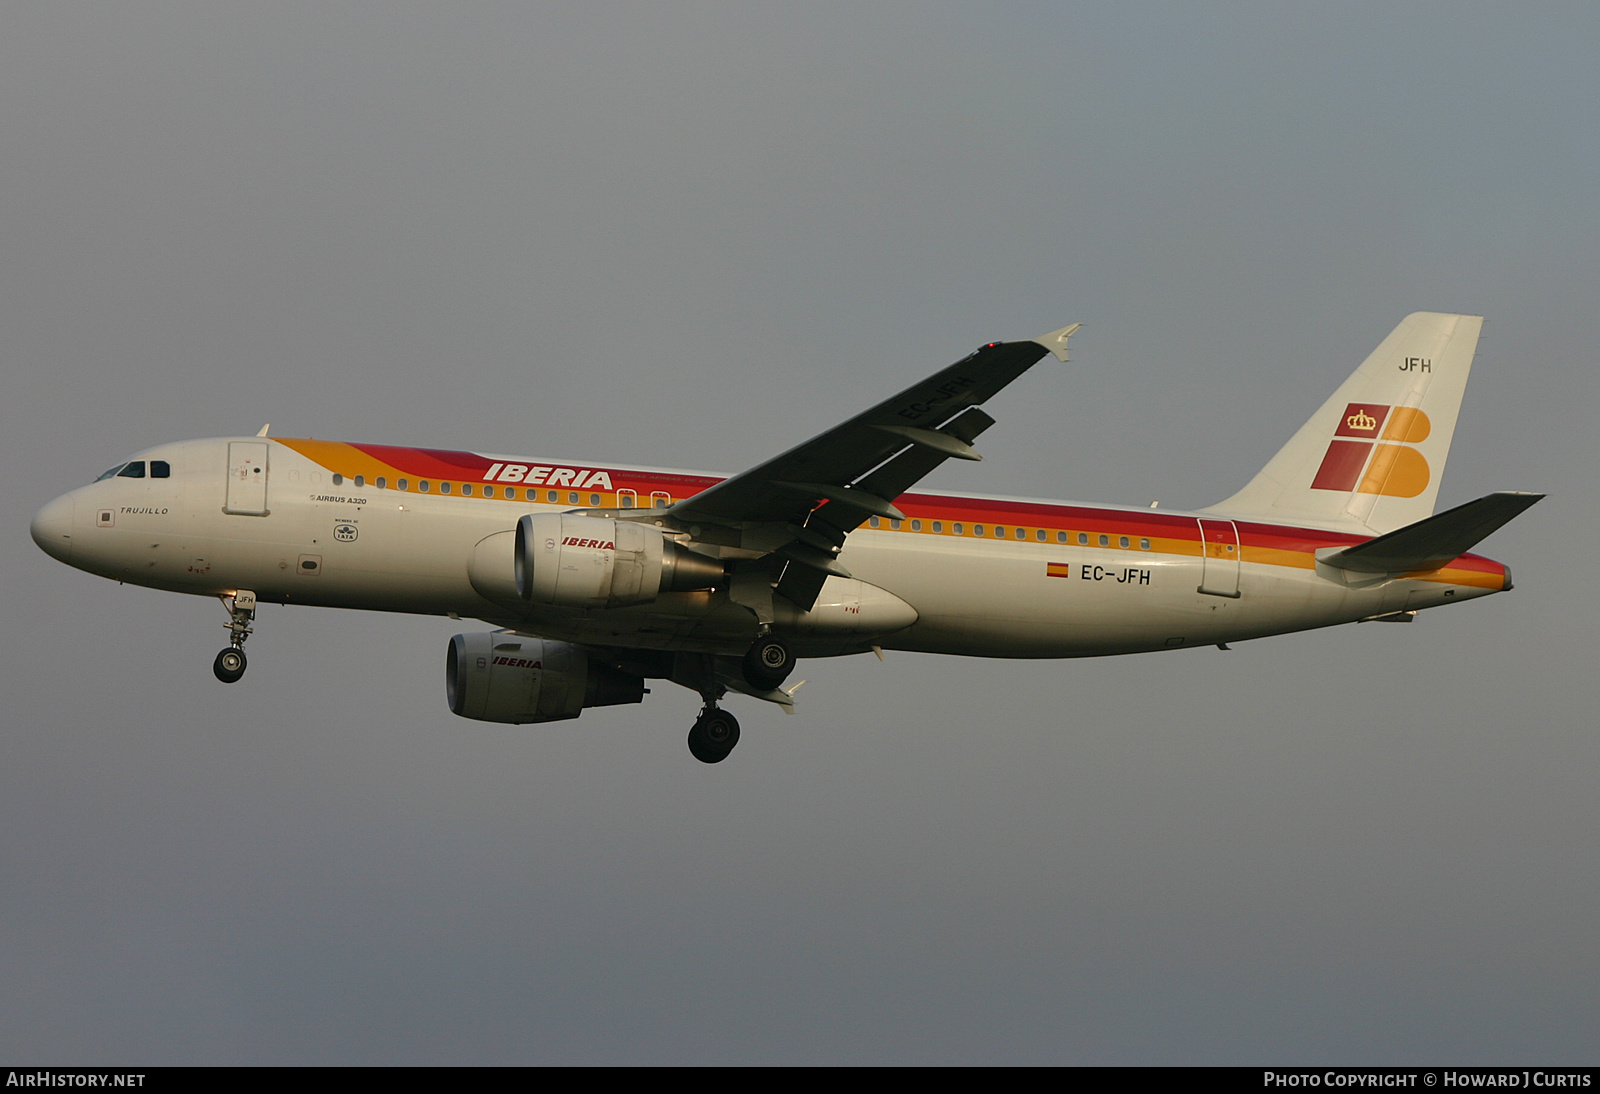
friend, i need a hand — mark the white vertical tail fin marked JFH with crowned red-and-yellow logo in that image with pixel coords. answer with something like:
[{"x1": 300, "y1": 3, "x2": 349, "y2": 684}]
[{"x1": 1203, "y1": 312, "x2": 1483, "y2": 533}]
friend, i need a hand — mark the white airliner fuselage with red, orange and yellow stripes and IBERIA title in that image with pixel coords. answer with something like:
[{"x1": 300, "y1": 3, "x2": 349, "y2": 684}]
[{"x1": 34, "y1": 438, "x2": 1509, "y2": 657}]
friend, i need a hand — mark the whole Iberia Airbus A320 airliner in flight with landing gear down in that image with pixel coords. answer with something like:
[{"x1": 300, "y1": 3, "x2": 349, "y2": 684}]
[{"x1": 32, "y1": 312, "x2": 1542, "y2": 763}]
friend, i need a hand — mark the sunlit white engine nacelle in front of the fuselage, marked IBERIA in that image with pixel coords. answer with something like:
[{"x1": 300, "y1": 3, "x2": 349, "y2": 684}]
[{"x1": 515, "y1": 513, "x2": 723, "y2": 608}]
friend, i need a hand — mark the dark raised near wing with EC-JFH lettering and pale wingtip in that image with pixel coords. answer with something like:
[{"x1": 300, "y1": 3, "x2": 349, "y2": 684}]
[{"x1": 656, "y1": 323, "x2": 1080, "y2": 614}]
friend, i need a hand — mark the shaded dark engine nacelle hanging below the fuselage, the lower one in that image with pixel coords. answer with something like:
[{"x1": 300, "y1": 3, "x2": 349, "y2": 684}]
[{"x1": 445, "y1": 630, "x2": 645, "y2": 725}]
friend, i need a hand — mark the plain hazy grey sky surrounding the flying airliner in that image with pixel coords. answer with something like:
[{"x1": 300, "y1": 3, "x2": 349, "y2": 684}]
[{"x1": 0, "y1": 3, "x2": 1600, "y2": 1064}]
